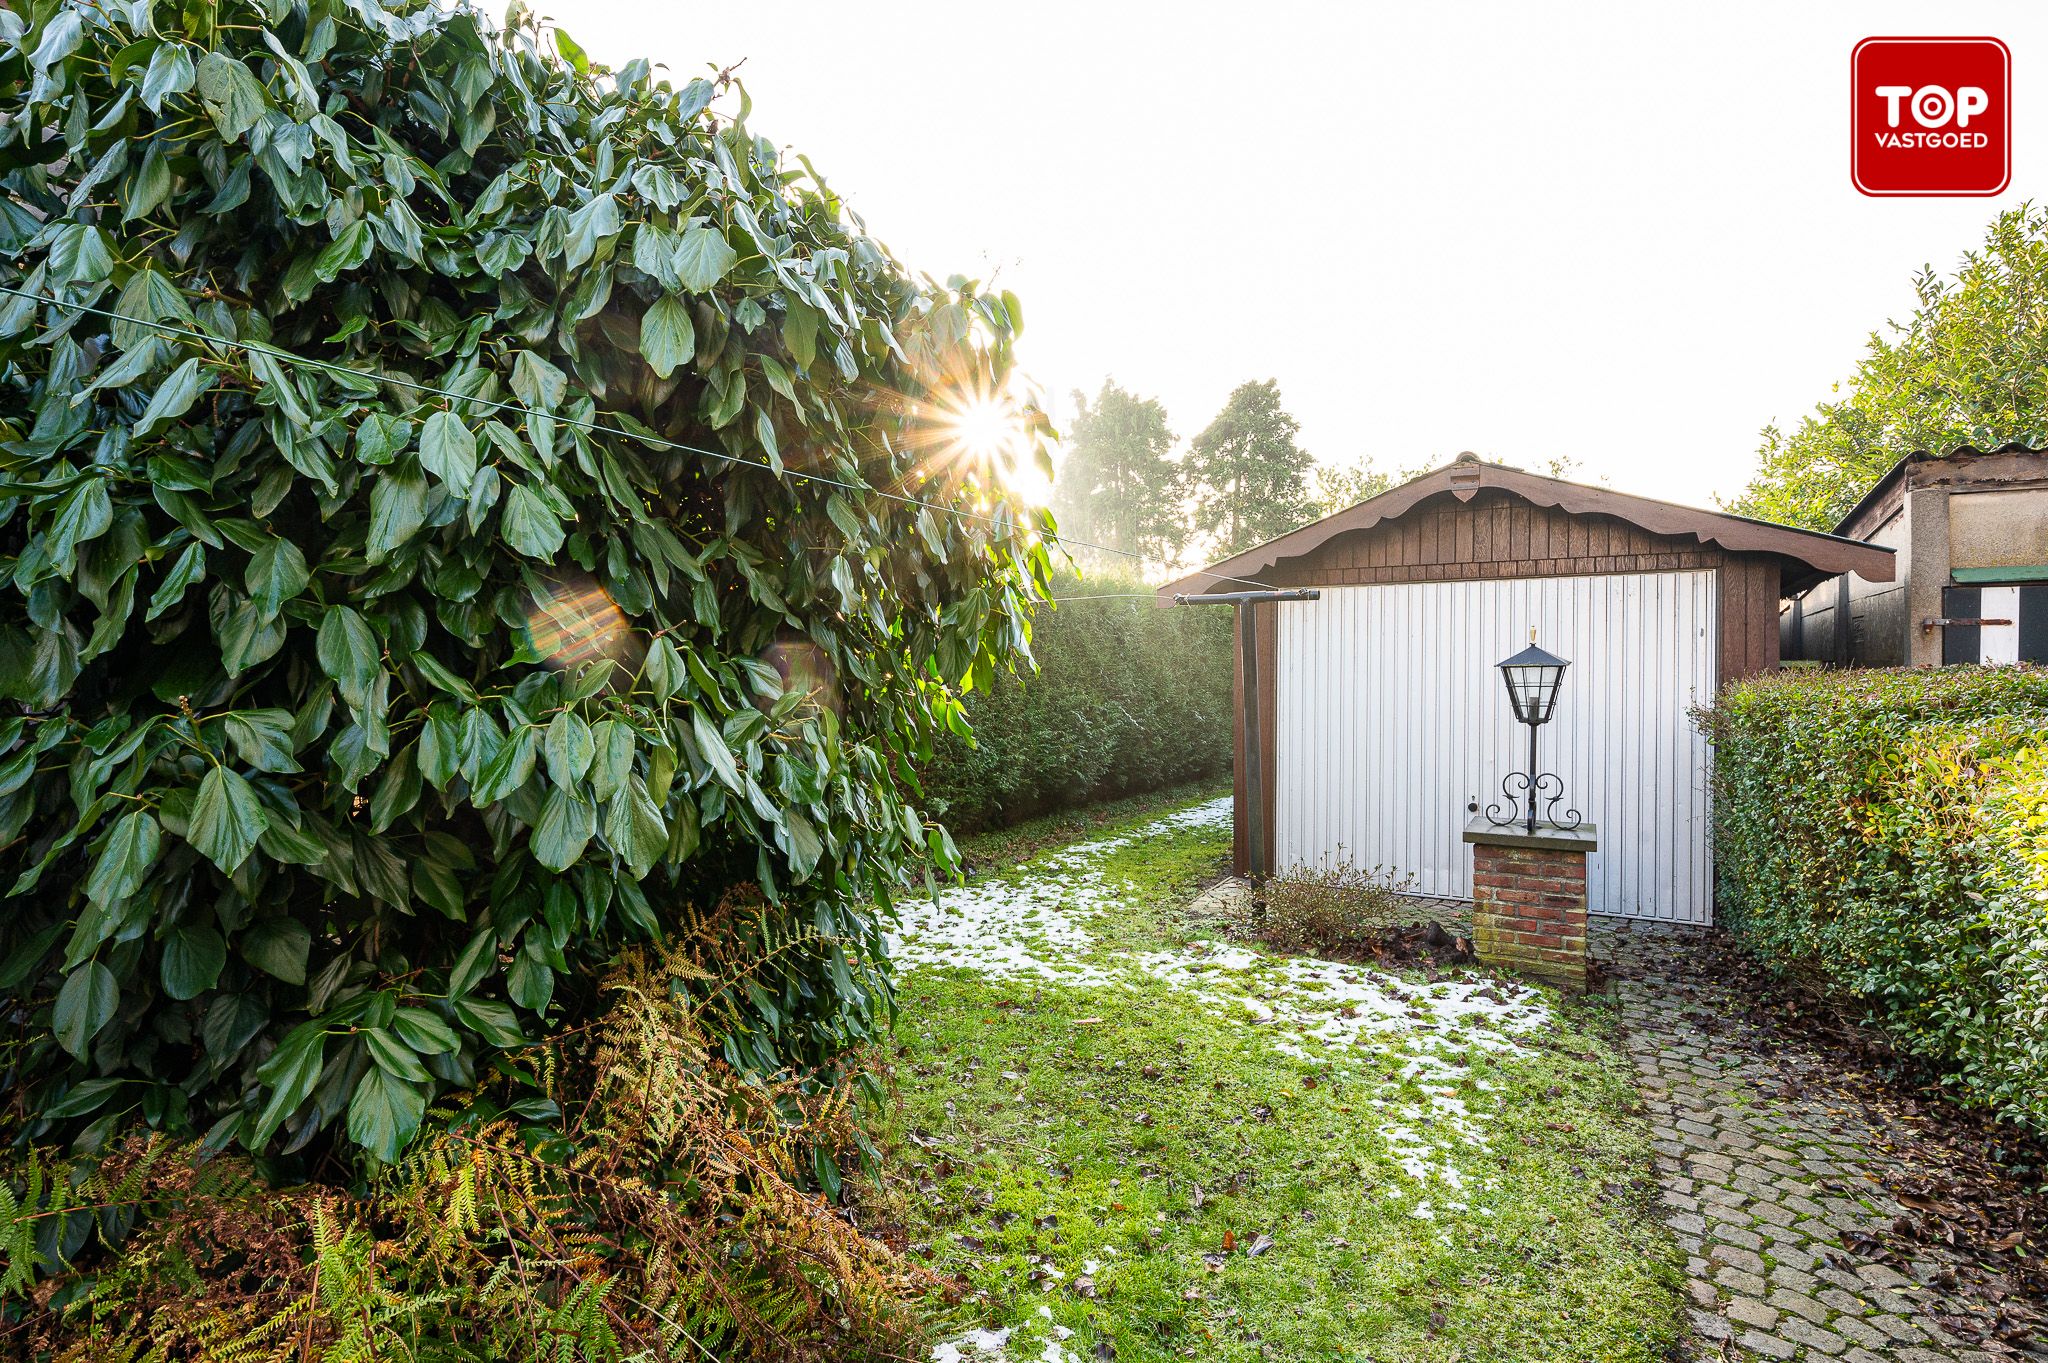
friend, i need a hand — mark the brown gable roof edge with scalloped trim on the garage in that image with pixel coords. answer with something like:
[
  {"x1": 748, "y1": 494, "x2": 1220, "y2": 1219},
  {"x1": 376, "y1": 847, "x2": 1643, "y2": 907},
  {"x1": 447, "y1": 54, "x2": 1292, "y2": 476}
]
[{"x1": 1159, "y1": 454, "x2": 1894, "y2": 600}]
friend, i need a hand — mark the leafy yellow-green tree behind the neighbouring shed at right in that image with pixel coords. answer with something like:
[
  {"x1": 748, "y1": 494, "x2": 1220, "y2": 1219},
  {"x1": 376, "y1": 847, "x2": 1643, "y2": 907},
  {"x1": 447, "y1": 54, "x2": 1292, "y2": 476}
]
[{"x1": 1729, "y1": 205, "x2": 2048, "y2": 530}]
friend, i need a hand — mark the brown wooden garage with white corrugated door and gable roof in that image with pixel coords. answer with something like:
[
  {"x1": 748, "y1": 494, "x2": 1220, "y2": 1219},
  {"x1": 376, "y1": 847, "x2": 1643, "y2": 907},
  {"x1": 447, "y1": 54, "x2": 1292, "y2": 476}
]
[{"x1": 1159, "y1": 454, "x2": 1892, "y2": 923}]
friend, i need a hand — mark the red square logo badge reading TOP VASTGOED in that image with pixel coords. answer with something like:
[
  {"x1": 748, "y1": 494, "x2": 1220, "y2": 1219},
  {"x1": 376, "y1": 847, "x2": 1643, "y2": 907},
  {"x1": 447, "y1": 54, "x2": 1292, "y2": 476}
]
[{"x1": 1849, "y1": 39, "x2": 2013, "y2": 196}]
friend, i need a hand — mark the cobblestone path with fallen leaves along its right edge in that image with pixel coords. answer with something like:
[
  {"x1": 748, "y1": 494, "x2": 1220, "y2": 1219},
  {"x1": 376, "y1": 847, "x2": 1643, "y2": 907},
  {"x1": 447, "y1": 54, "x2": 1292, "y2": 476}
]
[{"x1": 1591, "y1": 921, "x2": 2048, "y2": 1363}]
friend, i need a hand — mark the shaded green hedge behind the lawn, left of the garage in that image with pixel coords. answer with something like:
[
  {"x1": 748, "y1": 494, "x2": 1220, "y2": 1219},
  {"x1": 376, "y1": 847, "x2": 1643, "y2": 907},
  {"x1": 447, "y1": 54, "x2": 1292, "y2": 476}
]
[{"x1": 920, "y1": 577, "x2": 1231, "y2": 833}]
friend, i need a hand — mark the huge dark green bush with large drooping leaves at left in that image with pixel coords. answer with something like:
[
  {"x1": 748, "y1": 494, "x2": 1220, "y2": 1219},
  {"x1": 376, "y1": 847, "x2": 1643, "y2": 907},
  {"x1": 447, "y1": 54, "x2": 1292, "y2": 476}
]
[{"x1": 0, "y1": 0, "x2": 1051, "y2": 1169}]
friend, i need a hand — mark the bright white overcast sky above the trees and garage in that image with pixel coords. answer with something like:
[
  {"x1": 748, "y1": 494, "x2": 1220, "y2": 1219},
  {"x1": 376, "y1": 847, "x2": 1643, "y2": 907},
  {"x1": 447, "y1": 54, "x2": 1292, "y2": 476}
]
[{"x1": 537, "y1": 0, "x2": 2048, "y2": 505}]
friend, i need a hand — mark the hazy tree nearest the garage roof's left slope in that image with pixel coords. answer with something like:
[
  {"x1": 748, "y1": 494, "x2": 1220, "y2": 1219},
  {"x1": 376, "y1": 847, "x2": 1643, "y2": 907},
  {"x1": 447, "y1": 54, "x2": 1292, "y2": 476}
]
[{"x1": 1184, "y1": 379, "x2": 1315, "y2": 555}]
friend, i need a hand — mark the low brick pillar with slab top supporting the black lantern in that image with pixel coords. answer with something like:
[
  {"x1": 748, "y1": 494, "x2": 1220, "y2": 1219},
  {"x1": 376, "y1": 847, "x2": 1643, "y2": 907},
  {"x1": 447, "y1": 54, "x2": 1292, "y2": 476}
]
[{"x1": 1464, "y1": 819, "x2": 1597, "y2": 988}]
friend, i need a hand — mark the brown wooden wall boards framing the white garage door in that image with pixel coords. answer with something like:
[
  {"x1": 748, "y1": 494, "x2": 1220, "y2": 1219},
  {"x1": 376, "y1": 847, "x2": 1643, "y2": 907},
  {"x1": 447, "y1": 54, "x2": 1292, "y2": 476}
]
[{"x1": 1233, "y1": 487, "x2": 1782, "y2": 874}]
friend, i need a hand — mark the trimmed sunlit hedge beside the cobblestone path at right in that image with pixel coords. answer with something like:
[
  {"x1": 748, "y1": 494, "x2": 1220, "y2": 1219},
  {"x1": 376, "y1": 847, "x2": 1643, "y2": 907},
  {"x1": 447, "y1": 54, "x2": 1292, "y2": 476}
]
[{"x1": 1704, "y1": 667, "x2": 2048, "y2": 1132}]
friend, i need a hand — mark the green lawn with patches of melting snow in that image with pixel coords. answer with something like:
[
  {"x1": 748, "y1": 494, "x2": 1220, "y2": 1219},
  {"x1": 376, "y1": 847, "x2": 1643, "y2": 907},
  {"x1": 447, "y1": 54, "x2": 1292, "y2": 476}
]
[{"x1": 885, "y1": 796, "x2": 1681, "y2": 1363}]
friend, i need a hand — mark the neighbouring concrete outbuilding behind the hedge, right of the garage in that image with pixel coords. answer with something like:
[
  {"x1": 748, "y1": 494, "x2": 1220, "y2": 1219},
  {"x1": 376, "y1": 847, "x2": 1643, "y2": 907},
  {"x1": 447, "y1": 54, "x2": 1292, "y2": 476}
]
[{"x1": 1780, "y1": 444, "x2": 2048, "y2": 667}]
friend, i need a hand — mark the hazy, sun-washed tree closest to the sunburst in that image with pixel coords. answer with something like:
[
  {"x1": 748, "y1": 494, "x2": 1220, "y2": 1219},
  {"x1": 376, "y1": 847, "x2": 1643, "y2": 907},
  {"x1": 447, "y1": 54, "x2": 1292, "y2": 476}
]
[{"x1": 1053, "y1": 379, "x2": 1188, "y2": 561}]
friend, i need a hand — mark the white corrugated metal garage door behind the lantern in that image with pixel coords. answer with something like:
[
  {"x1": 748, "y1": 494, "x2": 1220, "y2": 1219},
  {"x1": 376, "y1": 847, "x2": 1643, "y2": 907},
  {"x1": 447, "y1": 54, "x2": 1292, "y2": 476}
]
[{"x1": 1274, "y1": 571, "x2": 1716, "y2": 923}]
